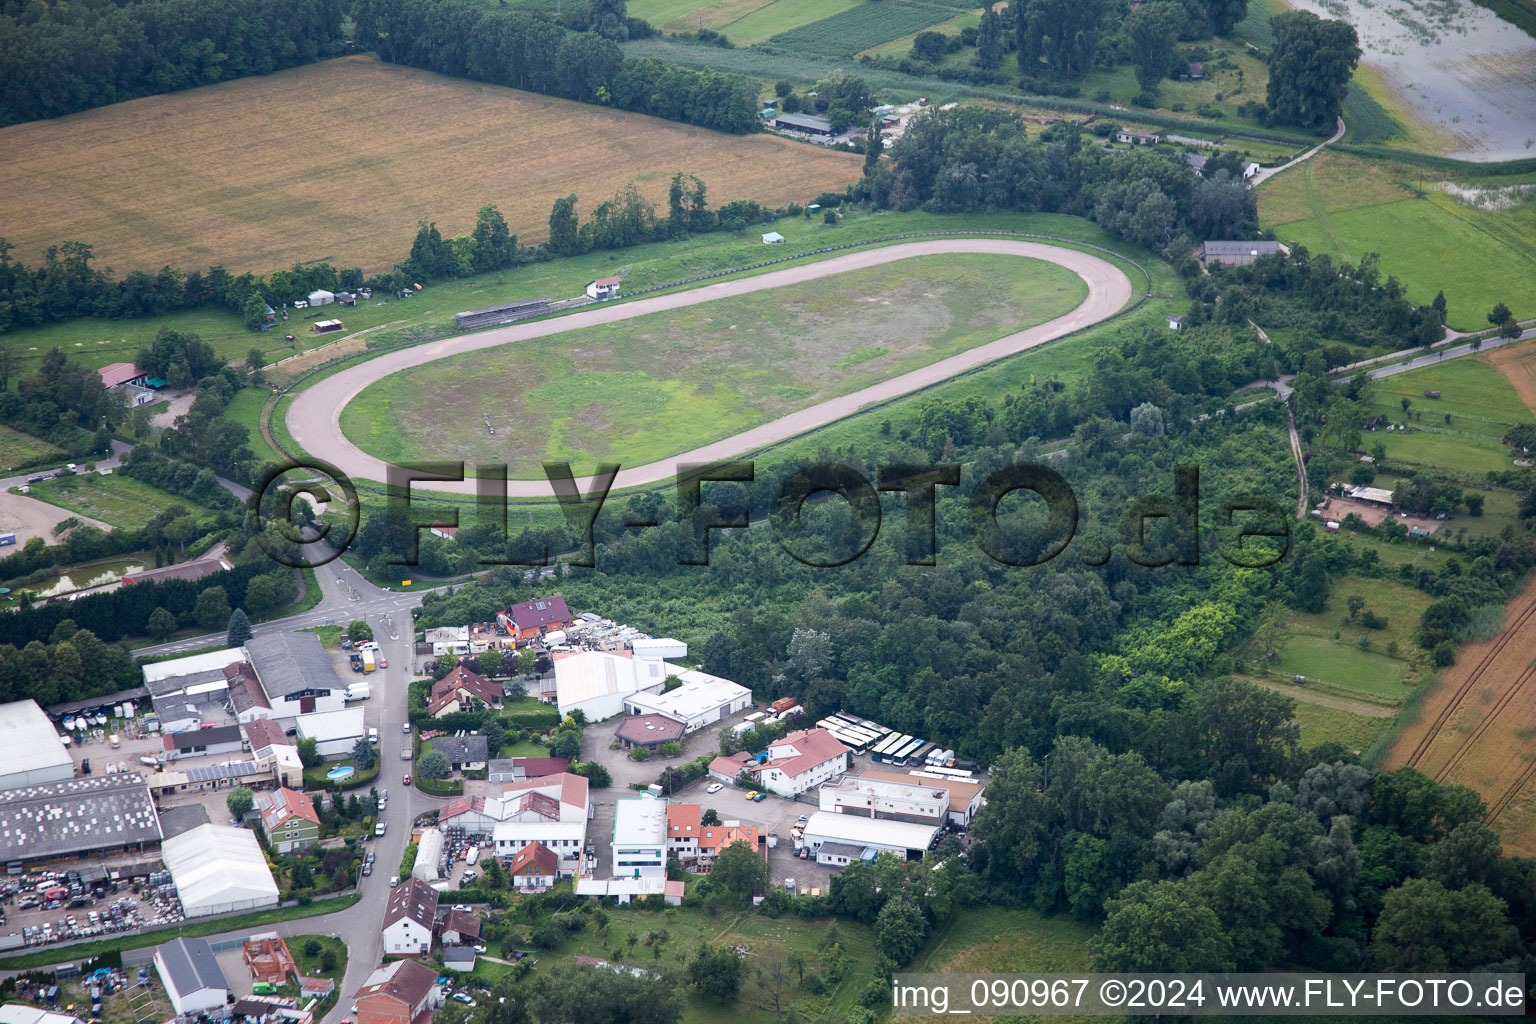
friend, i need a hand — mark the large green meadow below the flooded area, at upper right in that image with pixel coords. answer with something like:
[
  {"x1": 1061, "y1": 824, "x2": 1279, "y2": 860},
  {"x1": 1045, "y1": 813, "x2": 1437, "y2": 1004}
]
[{"x1": 1258, "y1": 152, "x2": 1536, "y2": 322}]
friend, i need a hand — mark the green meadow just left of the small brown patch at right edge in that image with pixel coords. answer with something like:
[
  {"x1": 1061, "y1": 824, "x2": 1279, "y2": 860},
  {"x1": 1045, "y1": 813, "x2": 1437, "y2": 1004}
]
[{"x1": 1364, "y1": 350, "x2": 1536, "y2": 481}]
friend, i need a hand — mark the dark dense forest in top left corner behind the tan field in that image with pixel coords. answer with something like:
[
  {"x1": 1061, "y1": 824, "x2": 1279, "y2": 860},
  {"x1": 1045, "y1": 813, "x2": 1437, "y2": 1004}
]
[{"x1": 0, "y1": 0, "x2": 343, "y2": 124}]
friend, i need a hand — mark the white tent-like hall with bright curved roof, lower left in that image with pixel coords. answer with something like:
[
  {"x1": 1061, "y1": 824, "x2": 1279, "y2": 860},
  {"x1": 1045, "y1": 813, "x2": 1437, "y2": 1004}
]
[{"x1": 160, "y1": 823, "x2": 278, "y2": 918}]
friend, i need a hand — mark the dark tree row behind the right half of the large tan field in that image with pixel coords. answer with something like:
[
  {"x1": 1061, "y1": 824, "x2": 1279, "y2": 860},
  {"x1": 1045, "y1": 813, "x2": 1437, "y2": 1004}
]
[{"x1": 352, "y1": 0, "x2": 757, "y2": 134}]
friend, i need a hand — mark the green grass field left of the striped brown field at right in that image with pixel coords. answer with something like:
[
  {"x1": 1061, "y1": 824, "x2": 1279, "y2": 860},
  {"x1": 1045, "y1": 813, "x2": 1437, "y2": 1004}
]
[{"x1": 1250, "y1": 576, "x2": 1430, "y2": 705}]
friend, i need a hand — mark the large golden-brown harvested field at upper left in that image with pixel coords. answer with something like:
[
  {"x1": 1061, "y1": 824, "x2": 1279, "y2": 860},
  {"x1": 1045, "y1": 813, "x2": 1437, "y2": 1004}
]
[{"x1": 0, "y1": 52, "x2": 860, "y2": 276}]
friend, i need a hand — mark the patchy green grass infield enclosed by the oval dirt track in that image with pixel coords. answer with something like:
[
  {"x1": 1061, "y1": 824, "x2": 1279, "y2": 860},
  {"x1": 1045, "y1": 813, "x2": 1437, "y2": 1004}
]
[{"x1": 341, "y1": 255, "x2": 1087, "y2": 477}]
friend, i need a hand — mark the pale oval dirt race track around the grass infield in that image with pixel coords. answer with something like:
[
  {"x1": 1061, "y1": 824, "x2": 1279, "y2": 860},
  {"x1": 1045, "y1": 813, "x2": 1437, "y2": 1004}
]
[{"x1": 287, "y1": 238, "x2": 1132, "y2": 497}]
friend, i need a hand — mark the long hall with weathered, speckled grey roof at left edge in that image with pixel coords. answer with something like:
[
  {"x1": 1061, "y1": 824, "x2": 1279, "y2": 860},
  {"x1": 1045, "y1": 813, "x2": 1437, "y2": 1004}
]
[{"x1": 0, "y1": 773, "x2": 163, "y2": 866}]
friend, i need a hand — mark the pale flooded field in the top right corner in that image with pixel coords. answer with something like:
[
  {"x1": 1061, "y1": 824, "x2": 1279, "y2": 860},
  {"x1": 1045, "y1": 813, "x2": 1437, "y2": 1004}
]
[{"x1": 1290, "y1": 0, "x2": 1536, "y2": 160}]
